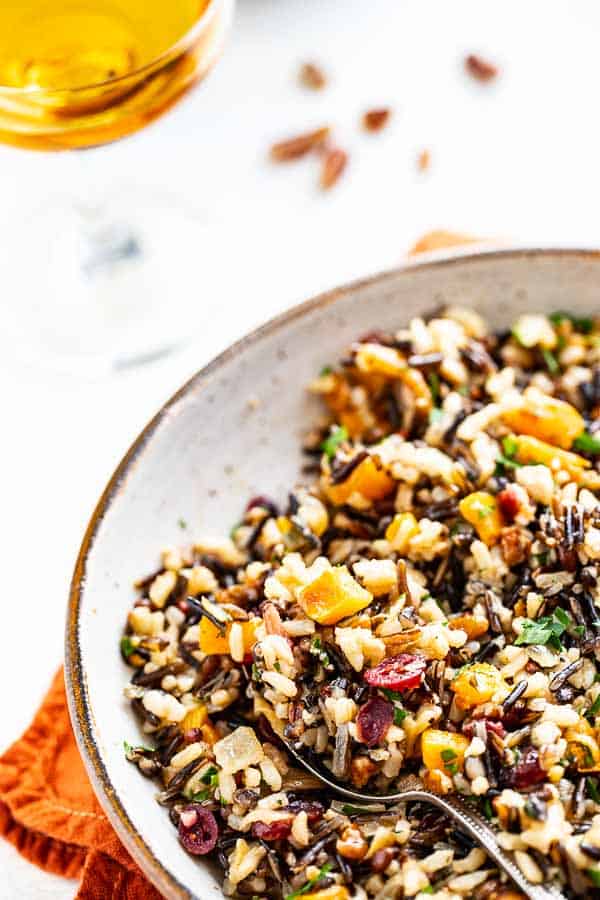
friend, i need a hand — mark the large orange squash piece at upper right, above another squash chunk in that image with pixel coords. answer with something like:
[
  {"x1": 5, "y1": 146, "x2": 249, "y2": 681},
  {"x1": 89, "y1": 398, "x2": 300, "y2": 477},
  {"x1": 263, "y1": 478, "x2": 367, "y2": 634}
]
[{"x1": 502, "y1": 388, "x2": 585, "y2": 450}]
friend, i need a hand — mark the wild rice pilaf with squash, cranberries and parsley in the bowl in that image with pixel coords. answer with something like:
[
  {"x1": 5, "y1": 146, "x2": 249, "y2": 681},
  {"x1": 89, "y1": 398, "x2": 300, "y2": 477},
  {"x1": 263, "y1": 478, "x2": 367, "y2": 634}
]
[{"x1": 121, "y1": 308, "x2": 600, "y2": 900}]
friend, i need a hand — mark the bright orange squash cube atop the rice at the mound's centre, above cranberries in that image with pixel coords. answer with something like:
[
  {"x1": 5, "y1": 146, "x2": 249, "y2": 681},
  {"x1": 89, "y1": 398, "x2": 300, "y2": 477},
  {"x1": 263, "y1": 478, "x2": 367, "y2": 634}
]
[{"x1": 298, "y1": 566, "x2": 373, "y2": 625}]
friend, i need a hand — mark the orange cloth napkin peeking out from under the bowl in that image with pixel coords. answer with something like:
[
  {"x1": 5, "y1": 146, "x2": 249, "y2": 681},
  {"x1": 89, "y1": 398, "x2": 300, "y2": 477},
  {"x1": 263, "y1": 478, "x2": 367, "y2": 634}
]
[{"x1": 0, "y1": 231, "x2": 475, "y2": 900}]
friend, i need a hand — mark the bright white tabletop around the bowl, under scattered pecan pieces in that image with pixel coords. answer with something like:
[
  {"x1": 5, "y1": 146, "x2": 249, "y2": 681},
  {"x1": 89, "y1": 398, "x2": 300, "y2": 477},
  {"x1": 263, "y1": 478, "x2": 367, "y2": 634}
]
[{"x1": 0, "y1": 0, "x2": 600, "y2": 900}]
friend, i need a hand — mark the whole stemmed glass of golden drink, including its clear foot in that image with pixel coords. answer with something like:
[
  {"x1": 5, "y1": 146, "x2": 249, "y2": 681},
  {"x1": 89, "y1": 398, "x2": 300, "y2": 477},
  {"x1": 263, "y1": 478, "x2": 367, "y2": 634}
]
[{"x1": 0, "y1": 0, "x2": 235, "y2": 375}]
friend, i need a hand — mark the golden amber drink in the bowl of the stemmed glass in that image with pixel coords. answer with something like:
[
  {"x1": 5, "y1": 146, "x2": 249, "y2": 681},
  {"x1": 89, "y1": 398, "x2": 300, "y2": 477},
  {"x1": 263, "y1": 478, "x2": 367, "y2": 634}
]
[{"x1": 0, "y1": 0, "x2": 226, "y2": 150}]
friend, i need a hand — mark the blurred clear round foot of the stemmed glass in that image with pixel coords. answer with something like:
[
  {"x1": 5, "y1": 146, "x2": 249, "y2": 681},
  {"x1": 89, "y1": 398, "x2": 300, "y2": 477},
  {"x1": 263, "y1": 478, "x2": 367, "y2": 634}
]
[{"x1": 0, "y1": 188, "x2": 223, "y2": 376}]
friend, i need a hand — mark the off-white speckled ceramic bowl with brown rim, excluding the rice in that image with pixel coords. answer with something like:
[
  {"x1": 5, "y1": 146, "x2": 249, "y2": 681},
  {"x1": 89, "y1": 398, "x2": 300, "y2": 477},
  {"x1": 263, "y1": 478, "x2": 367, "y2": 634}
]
[{"x1": 66, "y1": 250, "x2": 600, "y2": 900}]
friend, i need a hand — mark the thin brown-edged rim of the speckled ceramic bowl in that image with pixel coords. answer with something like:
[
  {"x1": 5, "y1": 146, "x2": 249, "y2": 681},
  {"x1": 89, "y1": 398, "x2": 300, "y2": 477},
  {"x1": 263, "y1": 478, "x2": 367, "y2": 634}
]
[{"x1": 65, "y1": 244, "x2": 600, "y2": 900}]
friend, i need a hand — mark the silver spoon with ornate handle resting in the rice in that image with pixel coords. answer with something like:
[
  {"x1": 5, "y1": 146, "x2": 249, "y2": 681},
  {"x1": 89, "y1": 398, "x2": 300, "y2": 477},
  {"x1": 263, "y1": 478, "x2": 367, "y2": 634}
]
[{"x1": 285, "y1": 741, "x2": 564, "y2": 900}]
